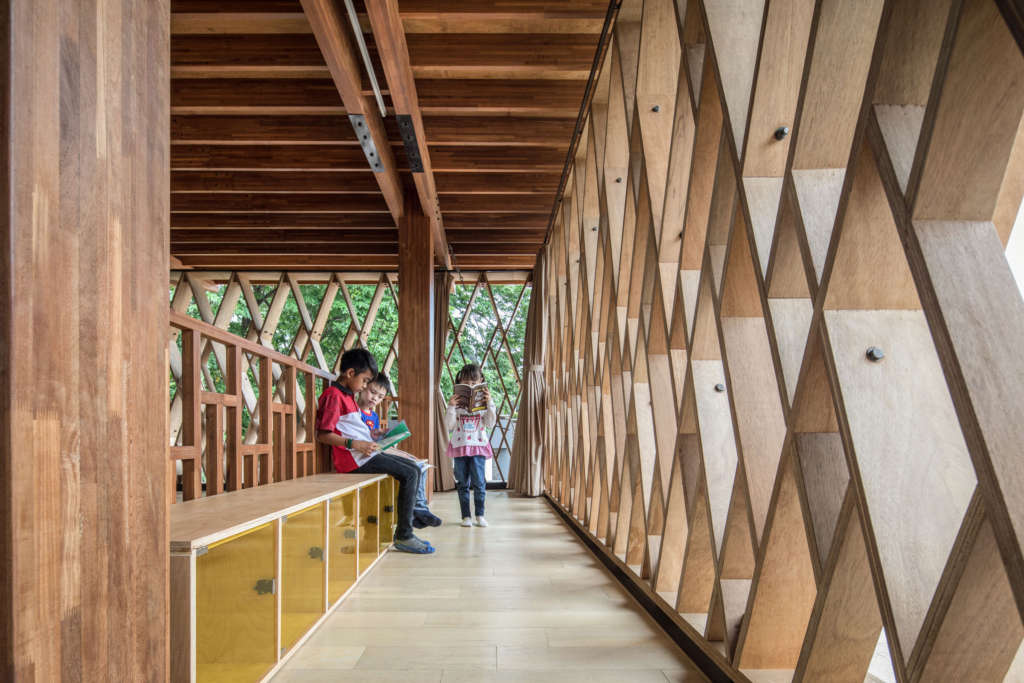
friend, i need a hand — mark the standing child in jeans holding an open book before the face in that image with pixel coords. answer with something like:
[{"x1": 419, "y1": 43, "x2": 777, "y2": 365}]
[{"x1": 444, "y1": 364, "x2": 498, "y2": 526}]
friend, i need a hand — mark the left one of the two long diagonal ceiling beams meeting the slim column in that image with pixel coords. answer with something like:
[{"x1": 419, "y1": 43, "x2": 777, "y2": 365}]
[{"x1": 301, "y1": 0, "x2": 404, "y2": 224}]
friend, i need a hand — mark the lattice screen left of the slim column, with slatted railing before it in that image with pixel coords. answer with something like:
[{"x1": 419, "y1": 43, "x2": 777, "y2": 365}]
[{"x1": 168, "y1": 271, "x2": 398, "y2": 500}]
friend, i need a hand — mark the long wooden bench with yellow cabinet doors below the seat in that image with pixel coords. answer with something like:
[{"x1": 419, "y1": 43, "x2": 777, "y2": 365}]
[{"x1": 170, "y1": 474, "x2": 397, "y2": 682}]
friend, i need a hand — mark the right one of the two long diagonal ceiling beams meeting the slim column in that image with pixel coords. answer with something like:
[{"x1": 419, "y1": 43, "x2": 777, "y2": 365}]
[{"x1": 366, "y1": 0, "x2": 452, "y2": 267}]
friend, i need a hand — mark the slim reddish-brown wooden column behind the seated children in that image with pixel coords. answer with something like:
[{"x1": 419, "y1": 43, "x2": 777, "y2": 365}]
[{"x1": 398, "y1": 195, "x2": 435, "y2": 481}]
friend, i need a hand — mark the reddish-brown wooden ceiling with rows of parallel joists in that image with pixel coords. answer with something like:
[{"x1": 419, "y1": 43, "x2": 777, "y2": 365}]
[{"x1": 170, "y1": 0, "x2": 608, "y2": 269}]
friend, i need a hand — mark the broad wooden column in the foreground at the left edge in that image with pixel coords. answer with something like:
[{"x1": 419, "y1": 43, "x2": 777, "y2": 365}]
[{"x1": 0, "y1": 0, "x2": 170, "y2": 681}]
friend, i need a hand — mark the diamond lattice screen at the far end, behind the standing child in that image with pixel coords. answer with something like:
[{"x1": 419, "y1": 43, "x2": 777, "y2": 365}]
[{"x1": 439, "y1": 272, "x2": 529, "y2": 481}]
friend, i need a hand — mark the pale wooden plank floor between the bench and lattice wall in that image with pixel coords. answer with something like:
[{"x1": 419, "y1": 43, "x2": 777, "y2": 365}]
[{"x1": 273, "y1": 492, "x2": 707, "y2": 683}]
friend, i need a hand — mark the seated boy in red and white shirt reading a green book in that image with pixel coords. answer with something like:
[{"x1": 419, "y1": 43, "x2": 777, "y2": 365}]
[{"x1": 316, "y1": 348, "x2": 434, "y2": 555}]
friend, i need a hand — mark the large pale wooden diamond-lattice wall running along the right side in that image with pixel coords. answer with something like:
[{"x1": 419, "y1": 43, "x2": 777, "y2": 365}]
[{"x1": 538, "y1": 0, "x2": 1024, "y2": 683}]
